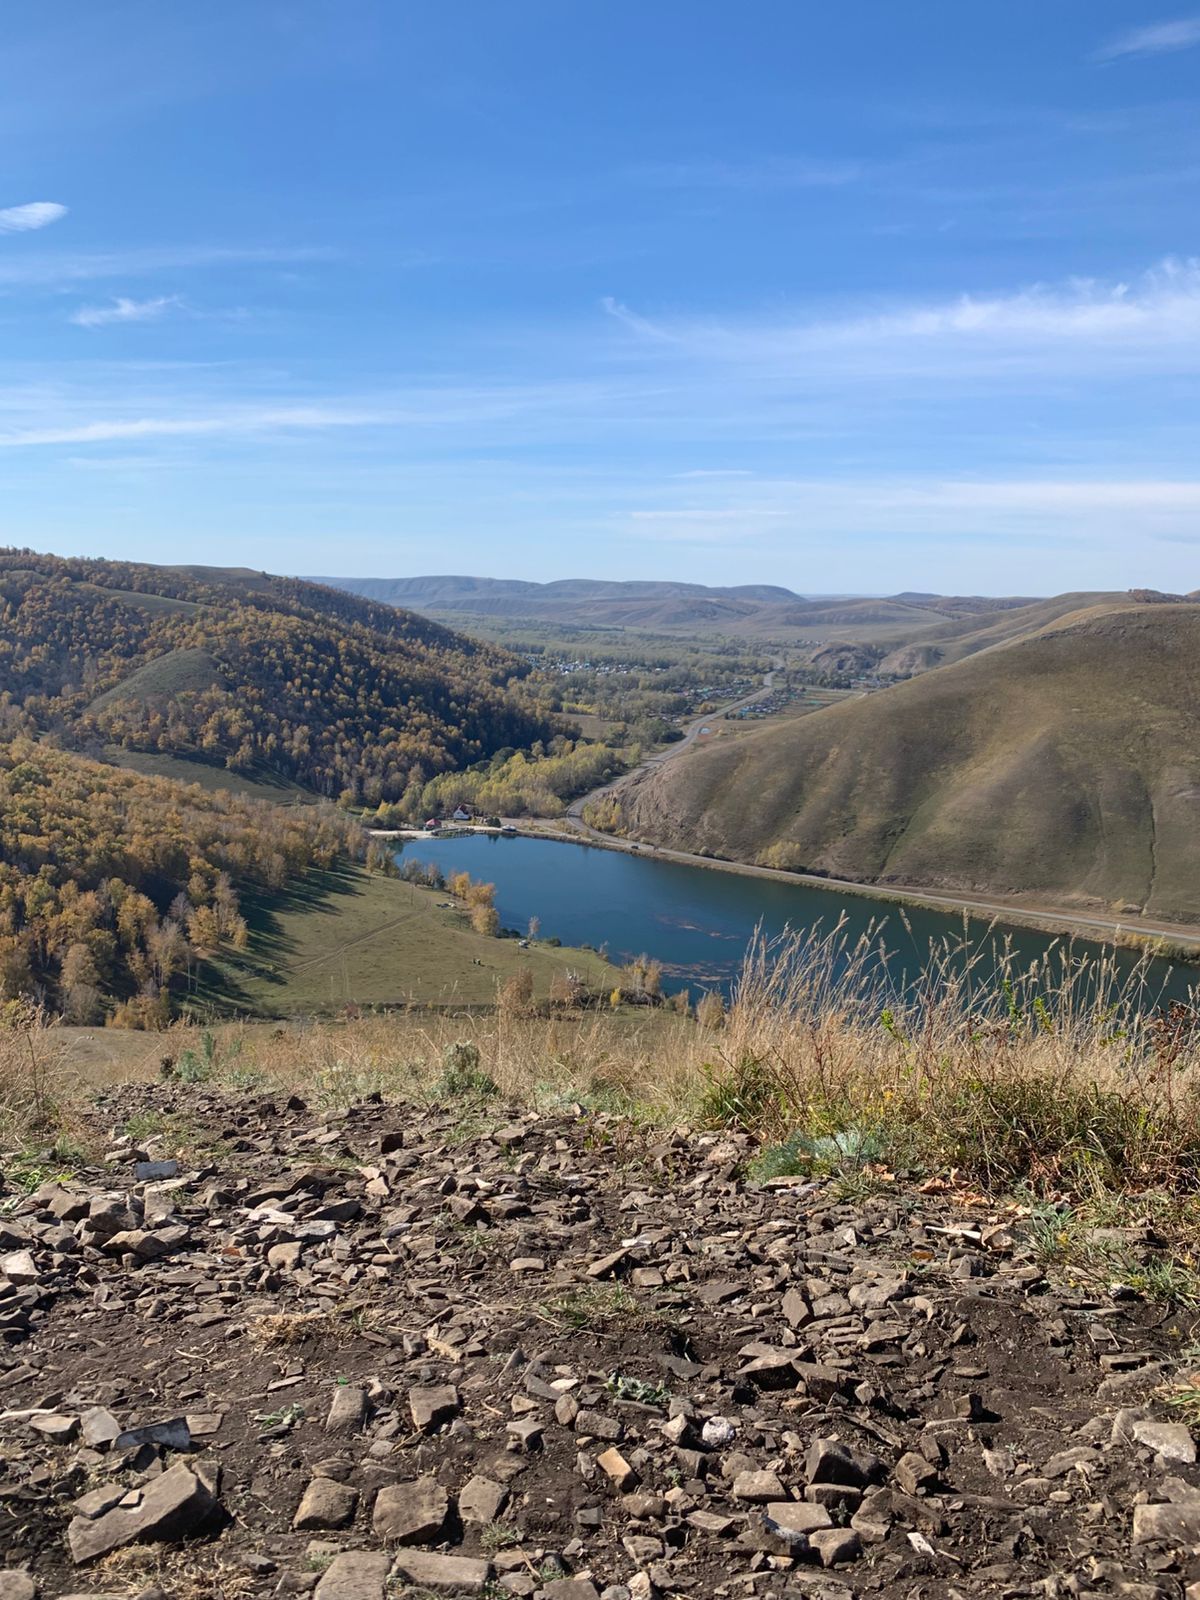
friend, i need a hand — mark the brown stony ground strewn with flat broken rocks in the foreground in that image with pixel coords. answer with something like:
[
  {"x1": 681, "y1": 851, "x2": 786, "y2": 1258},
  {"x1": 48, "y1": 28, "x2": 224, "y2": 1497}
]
[{"x1": 0, "y1": 1085, "x2": 1200, "y2": 1600}]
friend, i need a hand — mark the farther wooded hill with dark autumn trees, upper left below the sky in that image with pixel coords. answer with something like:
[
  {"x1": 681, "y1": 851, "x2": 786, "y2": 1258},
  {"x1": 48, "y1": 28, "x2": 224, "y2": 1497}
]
[{"x1": 0, "y1": 550, "x2": 554, "y2": 805}]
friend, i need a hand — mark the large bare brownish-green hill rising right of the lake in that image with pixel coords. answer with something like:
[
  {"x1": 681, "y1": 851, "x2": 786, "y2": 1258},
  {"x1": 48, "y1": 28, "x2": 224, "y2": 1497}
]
[{"x1": 624, "y1": 595, "x2": 1200, "y2": 920}]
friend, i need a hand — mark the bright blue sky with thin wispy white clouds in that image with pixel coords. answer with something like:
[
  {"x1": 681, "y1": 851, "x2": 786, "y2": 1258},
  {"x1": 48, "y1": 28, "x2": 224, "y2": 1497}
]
[{"x1": 0, "y1": 0, "x2": 1200, "y2": 594}]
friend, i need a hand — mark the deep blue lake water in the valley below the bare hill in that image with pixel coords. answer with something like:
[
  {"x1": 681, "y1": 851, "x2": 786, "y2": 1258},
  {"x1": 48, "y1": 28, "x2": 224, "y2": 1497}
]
[{"x1": 397, "y1": 834, "x2": 1200, "y2": 1000}]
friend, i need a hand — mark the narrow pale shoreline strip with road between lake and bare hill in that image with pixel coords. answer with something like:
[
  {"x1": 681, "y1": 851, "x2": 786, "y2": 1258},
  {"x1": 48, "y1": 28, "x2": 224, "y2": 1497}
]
[{"x1": 380, "y1": 813, "x2": 1200, "y2": 966}]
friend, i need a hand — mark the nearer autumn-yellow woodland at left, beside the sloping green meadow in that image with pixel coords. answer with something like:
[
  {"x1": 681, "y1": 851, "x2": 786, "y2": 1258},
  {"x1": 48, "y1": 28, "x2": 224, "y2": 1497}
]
[{"x1": 0, "y1": 736, "x2": 365, "y2": 1026}]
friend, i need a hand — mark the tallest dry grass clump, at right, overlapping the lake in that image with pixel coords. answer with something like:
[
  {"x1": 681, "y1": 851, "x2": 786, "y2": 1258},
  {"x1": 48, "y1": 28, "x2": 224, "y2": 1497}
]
[{"x1": 706, "y1": 925, "x2": 1200, "y2": 1189}]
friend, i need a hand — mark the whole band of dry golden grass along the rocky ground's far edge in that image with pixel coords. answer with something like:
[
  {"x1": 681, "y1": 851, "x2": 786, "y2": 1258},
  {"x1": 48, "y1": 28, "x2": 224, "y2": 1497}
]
[{"x1": 14, "y1": 925, "x2": 1200, "y2": 1195}]
